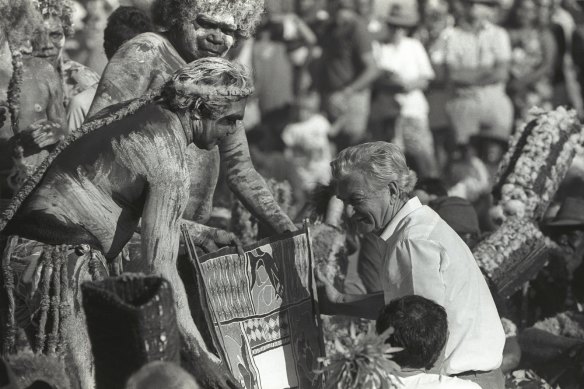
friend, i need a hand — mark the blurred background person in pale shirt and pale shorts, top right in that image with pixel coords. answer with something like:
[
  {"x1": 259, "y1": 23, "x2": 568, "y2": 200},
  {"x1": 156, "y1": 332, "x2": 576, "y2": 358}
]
[{"x1": 433, "y1": 0, "x2": 513, "y2": 164}]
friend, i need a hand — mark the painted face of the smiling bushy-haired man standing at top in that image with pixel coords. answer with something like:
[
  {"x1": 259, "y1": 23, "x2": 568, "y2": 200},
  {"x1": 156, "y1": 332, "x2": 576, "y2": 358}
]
[{"x1": 175, "y1": 14, "x2": 237, "y2": 62}]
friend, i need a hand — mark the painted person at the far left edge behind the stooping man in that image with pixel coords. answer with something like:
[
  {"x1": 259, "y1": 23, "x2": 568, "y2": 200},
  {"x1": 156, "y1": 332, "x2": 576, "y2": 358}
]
[{"x1": 0, "y1": 2, "x2": 66, "y2": 203}]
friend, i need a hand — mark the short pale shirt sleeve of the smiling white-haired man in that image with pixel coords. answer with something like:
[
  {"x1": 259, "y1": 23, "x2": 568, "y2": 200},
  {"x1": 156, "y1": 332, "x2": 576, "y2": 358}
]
[{"x1": 395, "y1": 239, "x2": 446, "y2": 306}]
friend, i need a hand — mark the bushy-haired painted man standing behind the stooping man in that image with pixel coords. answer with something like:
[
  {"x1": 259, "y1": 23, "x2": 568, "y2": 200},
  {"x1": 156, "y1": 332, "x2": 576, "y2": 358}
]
[{"x1": 88, "y1": 0, "x2": 295, "y2": 238}]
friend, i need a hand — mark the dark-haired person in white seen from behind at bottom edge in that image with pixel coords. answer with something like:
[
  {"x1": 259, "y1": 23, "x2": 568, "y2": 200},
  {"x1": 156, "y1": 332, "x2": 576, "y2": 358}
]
[{"x1": 376, "y1": 295, "x2": 480, "y2": 389}]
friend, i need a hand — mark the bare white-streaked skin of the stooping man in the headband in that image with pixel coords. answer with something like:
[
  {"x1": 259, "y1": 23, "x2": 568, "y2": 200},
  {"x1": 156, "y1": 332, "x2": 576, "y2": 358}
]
[{"x1": 3, "y1": 100, "x2": 245, "y2": 388}]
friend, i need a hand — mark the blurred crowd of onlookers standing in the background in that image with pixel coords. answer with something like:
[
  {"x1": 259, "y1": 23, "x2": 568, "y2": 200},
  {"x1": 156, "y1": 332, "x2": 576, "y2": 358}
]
[{"x1": 6, "y1": 0, "x2": 584, "y2": 230}]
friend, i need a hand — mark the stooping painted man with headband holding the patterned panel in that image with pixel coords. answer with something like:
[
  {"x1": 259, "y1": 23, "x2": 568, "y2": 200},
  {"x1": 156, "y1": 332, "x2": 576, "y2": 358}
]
[{"x1": 0, "y1": 58, "x2": 253, "y2": 388}]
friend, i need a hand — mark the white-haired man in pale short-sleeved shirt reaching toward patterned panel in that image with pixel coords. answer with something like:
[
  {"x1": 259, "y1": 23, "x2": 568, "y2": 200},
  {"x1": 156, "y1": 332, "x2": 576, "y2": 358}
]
[{"x1": 319, "y1": 142, "x2": 505, "y2": 389}]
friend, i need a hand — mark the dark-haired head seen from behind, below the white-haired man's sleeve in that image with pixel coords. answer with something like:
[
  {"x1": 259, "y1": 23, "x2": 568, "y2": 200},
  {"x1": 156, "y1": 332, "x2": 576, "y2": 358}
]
[{"x1": 376, "y1": 295, "x2": 448, "y2": 369}]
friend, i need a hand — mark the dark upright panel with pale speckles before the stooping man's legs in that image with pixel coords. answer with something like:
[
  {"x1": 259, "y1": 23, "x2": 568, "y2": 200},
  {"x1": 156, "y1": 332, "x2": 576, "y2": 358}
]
[{"x1": 81, "y1": 274, "x2": 180, "y2": 389}]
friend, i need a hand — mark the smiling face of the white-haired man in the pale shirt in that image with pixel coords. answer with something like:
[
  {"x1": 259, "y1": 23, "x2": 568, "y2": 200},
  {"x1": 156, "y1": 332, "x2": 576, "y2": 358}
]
[{"x1": 336, "y1": 172, "x2": 392, "y2": 233}]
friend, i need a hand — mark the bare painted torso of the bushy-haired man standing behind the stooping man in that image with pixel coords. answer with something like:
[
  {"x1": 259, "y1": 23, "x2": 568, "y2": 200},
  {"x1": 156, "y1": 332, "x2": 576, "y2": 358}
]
[{"x1": 88, "y1": 33, "x2": 219, "y2": 223}]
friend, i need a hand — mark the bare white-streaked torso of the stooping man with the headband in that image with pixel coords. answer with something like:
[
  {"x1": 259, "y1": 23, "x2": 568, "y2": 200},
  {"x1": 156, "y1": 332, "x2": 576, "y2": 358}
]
[{"x1": 8, "y1": 104, "x2": 189, "y2": 259}]
